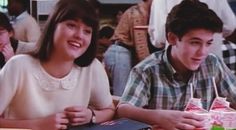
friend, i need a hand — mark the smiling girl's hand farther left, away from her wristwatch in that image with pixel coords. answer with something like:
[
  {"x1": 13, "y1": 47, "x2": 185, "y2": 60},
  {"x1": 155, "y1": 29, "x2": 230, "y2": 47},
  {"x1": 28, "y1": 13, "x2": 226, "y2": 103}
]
[{"x1": 33, "y1": 113, "x2": 69, "y2": 130}]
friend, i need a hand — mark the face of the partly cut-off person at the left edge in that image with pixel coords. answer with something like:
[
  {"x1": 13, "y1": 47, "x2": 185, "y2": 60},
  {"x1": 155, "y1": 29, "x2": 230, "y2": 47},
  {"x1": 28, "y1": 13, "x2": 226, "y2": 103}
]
[{"x1": 0, "y1": 27, "x2": 12, "y2": 52}]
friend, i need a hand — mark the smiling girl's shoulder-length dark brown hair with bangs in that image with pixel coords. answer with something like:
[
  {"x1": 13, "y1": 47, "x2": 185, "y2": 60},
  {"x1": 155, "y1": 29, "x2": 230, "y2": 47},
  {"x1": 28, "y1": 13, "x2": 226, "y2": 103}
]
[{"x1": 32, "y1": 0, "x2": 98, "y2": 67}]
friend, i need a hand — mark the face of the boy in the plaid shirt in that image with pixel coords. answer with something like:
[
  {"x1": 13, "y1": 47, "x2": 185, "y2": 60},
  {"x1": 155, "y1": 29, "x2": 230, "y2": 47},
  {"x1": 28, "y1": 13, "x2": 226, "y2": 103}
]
[{"x1": 168, "y1": 29, "x2": 214, "y2": 72}]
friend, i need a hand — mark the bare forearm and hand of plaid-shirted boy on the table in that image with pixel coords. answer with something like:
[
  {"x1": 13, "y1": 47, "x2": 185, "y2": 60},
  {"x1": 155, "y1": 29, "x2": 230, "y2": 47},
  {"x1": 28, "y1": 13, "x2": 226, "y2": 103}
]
[{"x1": 117, "y1": 104, "x2": 203, "y2": 130}]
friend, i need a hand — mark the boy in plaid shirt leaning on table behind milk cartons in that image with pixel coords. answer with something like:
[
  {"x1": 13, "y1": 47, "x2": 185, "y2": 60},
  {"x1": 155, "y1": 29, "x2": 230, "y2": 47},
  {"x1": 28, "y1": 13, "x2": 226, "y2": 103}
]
[{"x1": 117, "y1": 0, "x2": 236, "y2": 130}]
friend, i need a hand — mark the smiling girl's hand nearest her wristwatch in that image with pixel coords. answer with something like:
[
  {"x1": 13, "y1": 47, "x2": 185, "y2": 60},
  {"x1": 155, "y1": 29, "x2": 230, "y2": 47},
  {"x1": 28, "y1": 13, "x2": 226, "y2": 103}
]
[{"x1": 65, "y1": 106, "x2": 92, "y2": 126}]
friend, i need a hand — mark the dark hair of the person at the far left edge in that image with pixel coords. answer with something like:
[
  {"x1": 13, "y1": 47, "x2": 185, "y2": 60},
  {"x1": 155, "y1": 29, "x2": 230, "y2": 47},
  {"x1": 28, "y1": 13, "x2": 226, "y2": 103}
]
[{"x1": 0, "y1": 12, "x2": 13, "y2": 32}]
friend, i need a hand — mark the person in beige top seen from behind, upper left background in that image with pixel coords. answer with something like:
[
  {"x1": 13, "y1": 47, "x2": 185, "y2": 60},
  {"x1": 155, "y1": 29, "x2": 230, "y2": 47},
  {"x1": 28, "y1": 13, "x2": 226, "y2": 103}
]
[{"x1": 7, "y1": 0, "x2": 41, "y2": 43}]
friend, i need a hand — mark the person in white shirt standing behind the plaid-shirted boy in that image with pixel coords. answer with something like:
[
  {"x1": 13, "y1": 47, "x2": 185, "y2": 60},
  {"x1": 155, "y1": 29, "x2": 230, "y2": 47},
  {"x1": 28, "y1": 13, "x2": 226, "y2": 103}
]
[{"x1": 149, "y1": 0, "x2": 236, "y2": 58}]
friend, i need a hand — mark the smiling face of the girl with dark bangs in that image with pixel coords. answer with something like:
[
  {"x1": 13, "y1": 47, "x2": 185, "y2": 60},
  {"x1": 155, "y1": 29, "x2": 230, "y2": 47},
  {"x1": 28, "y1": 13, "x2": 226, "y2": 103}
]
[{"x1": 53, "y1": 20, "x2": 93, "y2": 60}]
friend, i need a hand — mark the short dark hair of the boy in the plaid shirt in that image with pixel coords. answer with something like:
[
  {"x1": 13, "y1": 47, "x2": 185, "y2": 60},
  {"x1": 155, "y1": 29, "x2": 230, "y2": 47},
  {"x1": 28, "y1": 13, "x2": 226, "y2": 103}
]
[{"x1": 166, "y1": 0, "x2": 223, "y2": 40}]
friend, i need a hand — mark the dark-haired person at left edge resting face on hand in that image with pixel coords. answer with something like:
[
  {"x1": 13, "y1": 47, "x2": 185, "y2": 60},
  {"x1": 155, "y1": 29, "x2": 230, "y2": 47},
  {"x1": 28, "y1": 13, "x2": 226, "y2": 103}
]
[{"x1": 0, "y1": 12, "x2": 35, "y2": 69}]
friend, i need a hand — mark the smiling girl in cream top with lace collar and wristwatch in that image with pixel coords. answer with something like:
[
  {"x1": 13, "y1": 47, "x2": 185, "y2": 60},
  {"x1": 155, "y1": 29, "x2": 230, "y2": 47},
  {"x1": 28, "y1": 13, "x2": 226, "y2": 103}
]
[{"x1": 0, "y1": 0, "x2": 115, "y2": 130}]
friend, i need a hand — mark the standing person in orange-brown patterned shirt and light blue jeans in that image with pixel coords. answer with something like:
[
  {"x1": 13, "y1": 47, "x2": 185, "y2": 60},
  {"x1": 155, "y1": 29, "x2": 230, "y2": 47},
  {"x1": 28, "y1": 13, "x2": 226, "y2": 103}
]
[{"x1": 104, "y1": 0, "x2": 157, "y2": 96}]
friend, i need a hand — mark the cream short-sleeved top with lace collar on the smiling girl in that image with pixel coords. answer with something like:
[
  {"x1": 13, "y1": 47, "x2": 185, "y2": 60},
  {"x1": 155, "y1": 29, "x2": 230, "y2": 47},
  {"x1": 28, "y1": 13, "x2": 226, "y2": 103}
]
[{"x1": 0, "y1": 55, "x2": 112, "y2": 119}]
